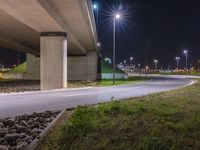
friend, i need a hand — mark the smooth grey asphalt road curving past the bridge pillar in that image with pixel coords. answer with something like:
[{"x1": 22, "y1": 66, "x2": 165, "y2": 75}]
[{"x1": 0, "y1": 77, "x2": 192, "y2": 118}]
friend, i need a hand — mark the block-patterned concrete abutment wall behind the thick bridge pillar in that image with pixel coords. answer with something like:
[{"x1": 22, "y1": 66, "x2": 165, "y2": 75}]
[{"x1": 24, "y1": 51, "x2": 97, "y2": 81}]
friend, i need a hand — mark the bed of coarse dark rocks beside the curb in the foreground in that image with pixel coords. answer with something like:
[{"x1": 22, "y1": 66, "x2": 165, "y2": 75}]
[{"x1": 0, "y1": 111, "x2": 60, "y2": 150}]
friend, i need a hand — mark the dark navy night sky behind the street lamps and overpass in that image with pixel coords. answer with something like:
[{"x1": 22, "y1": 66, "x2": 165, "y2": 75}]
[{"x1": 0, "y1": 0, "x2": 200, "y2": 67}]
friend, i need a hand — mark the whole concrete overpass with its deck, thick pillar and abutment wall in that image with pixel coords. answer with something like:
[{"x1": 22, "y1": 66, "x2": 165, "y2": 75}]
[{"x1": 0, "y1": 0, "x2": 97, "y2": 90}]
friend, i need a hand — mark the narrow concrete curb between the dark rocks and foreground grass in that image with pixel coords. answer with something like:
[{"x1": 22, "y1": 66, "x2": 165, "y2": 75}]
[{"x1": 27, "y1": 109, "x2": 66, "y2": 150}]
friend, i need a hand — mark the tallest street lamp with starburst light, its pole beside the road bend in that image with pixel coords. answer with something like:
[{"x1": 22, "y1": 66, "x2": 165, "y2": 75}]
[{"x1": 113, "y1": 13, "x2": 121, "y2": 84}]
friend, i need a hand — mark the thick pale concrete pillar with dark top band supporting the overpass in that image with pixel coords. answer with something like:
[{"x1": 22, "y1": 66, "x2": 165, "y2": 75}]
[{"x1": 40, "y1": 32, "x2": 67, "y2": 90}]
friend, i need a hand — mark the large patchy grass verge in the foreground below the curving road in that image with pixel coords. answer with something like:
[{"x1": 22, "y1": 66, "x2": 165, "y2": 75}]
[{"x1": 37, "y1": 81, "x2": 200, "y2": 150}]
